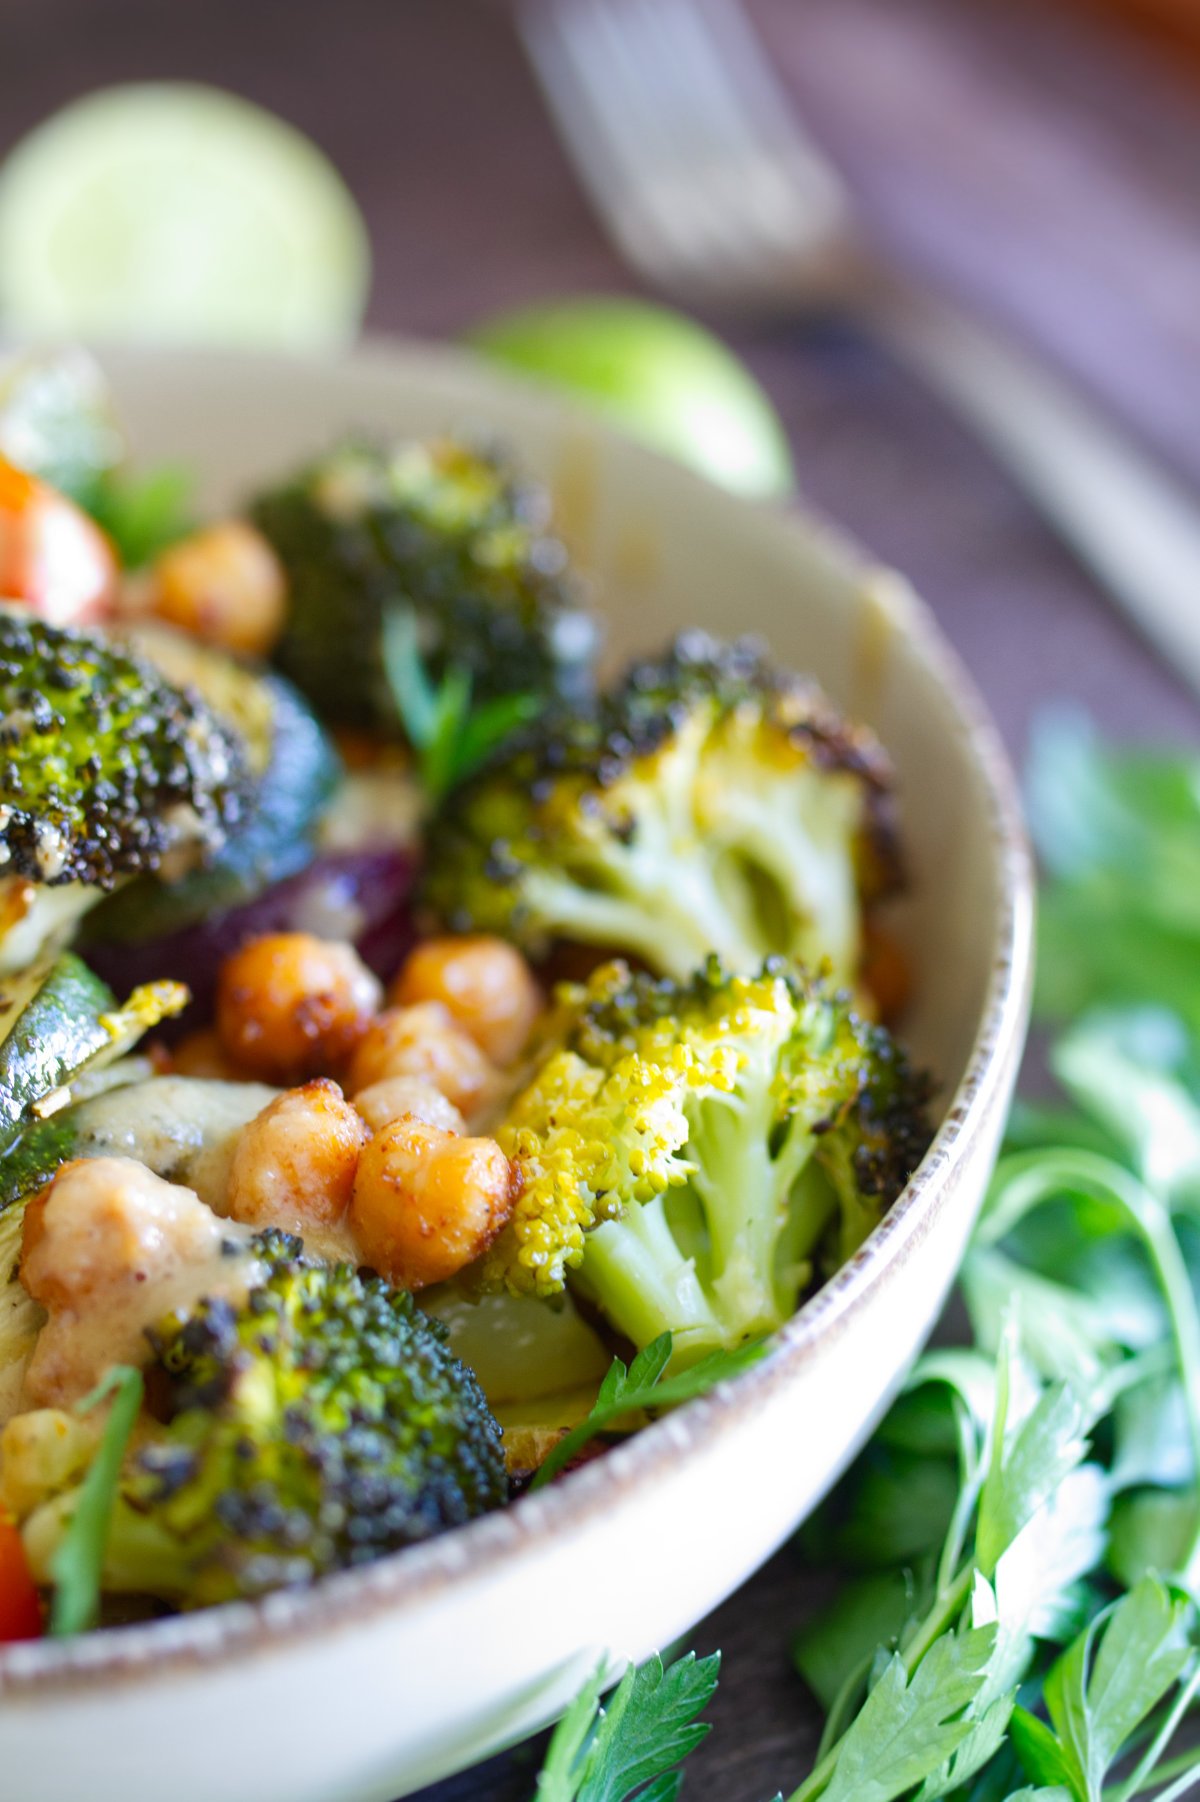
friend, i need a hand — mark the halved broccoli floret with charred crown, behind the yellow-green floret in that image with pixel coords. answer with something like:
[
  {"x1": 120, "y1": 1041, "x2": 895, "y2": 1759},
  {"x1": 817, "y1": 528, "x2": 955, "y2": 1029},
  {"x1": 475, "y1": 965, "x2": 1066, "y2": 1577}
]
[{"x1": 425, "y1": 633, "x2": 899, "y2": 980}]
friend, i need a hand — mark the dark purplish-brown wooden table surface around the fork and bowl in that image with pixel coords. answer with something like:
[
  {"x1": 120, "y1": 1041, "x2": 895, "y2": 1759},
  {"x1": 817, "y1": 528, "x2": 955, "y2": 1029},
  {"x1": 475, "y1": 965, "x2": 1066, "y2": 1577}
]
[{"x1": 0, "y1": 0, "x2": 1200, "y2": 1802}]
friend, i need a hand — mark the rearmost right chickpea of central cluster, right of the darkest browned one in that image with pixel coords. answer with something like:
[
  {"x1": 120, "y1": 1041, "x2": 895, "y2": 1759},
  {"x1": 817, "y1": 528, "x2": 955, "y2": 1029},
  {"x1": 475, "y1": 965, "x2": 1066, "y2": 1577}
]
[{"x1": 387, "y1": 933, "x2": 542, "y2": 1065}]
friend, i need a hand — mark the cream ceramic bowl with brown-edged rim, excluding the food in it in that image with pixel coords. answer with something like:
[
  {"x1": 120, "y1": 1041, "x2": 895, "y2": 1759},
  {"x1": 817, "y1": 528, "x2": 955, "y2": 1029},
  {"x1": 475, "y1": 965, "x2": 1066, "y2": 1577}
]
[{"x1": 0, "y1": 346, "x2": 1031, "y2": 1802}]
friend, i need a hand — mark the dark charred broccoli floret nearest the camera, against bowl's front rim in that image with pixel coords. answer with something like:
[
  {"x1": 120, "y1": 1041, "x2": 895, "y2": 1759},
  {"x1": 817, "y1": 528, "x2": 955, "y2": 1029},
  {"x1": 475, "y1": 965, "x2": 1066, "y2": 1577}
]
[{"x1": 25, "y1": 1229, "x2": 508, "y2": 1607}]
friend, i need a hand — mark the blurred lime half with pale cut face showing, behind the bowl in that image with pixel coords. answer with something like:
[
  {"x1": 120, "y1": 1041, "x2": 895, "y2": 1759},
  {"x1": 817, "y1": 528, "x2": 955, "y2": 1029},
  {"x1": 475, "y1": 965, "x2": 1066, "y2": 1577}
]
[{"x1": 0, "y1": 83, "x2": 369, "y2": 350}]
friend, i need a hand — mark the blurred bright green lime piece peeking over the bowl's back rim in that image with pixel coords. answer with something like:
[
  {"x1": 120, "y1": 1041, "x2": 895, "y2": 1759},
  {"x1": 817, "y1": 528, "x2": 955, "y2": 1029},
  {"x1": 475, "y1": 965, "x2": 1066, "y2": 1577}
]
[{"x1": 470, "y1": 297, "x2": 795, "y2": 499}]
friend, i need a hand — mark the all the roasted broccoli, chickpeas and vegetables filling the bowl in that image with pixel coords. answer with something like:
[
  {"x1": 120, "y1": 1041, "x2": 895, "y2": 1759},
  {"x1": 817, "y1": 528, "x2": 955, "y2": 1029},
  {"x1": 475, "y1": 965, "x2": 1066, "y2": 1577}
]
[{"x1": 0, "y1": 347, "x2": 932, "y2": 1640}]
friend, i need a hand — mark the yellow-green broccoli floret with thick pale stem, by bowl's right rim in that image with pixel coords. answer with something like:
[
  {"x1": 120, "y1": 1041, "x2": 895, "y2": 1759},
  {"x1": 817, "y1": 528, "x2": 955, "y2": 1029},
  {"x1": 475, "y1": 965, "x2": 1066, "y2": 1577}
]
[{"x1": 483, "y1": 959, "x2": 930, "y2": 1357}]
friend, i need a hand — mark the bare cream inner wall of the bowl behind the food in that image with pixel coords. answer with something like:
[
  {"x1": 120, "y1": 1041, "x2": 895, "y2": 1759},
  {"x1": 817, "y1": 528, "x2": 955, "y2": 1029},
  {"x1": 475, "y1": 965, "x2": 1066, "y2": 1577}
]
[{"x1": 105, "y1": 346, "x2": 1007, "y2": 1101}]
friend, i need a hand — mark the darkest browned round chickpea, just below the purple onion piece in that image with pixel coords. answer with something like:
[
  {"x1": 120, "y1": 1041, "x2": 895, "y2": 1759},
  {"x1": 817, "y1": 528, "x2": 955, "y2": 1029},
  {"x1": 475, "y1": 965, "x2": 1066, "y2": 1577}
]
[{"x1": 216, "y1": 932, "x2": 380, "y2": 1088}]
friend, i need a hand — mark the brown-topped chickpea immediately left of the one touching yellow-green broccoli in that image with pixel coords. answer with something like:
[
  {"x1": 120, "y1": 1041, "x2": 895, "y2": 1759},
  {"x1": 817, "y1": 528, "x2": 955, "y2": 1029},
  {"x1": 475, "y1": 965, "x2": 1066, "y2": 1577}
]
[{"x1": 225, "y1": 1078, "x2": 369, "y2": 1238}]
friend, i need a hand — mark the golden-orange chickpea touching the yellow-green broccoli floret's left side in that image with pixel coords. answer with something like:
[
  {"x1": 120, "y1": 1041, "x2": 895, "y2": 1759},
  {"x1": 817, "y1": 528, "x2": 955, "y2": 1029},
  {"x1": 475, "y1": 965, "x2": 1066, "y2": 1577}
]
[{"x1": 350, "y1": 1117, "x2": 515, "y2": 1288}]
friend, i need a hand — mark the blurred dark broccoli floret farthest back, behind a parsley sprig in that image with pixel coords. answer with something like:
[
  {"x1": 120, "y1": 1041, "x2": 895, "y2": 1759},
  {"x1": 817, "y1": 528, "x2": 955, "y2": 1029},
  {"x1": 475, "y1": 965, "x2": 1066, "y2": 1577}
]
[{"x1": 252, "y1": 438, "x2": 596, "y2": 735}]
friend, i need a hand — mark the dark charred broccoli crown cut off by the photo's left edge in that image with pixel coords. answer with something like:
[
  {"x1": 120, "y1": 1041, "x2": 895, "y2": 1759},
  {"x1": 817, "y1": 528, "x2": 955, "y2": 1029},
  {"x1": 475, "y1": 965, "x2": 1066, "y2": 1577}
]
[{"x1": 0, "y1": 607, "x2": 243, "y2": 888}]
